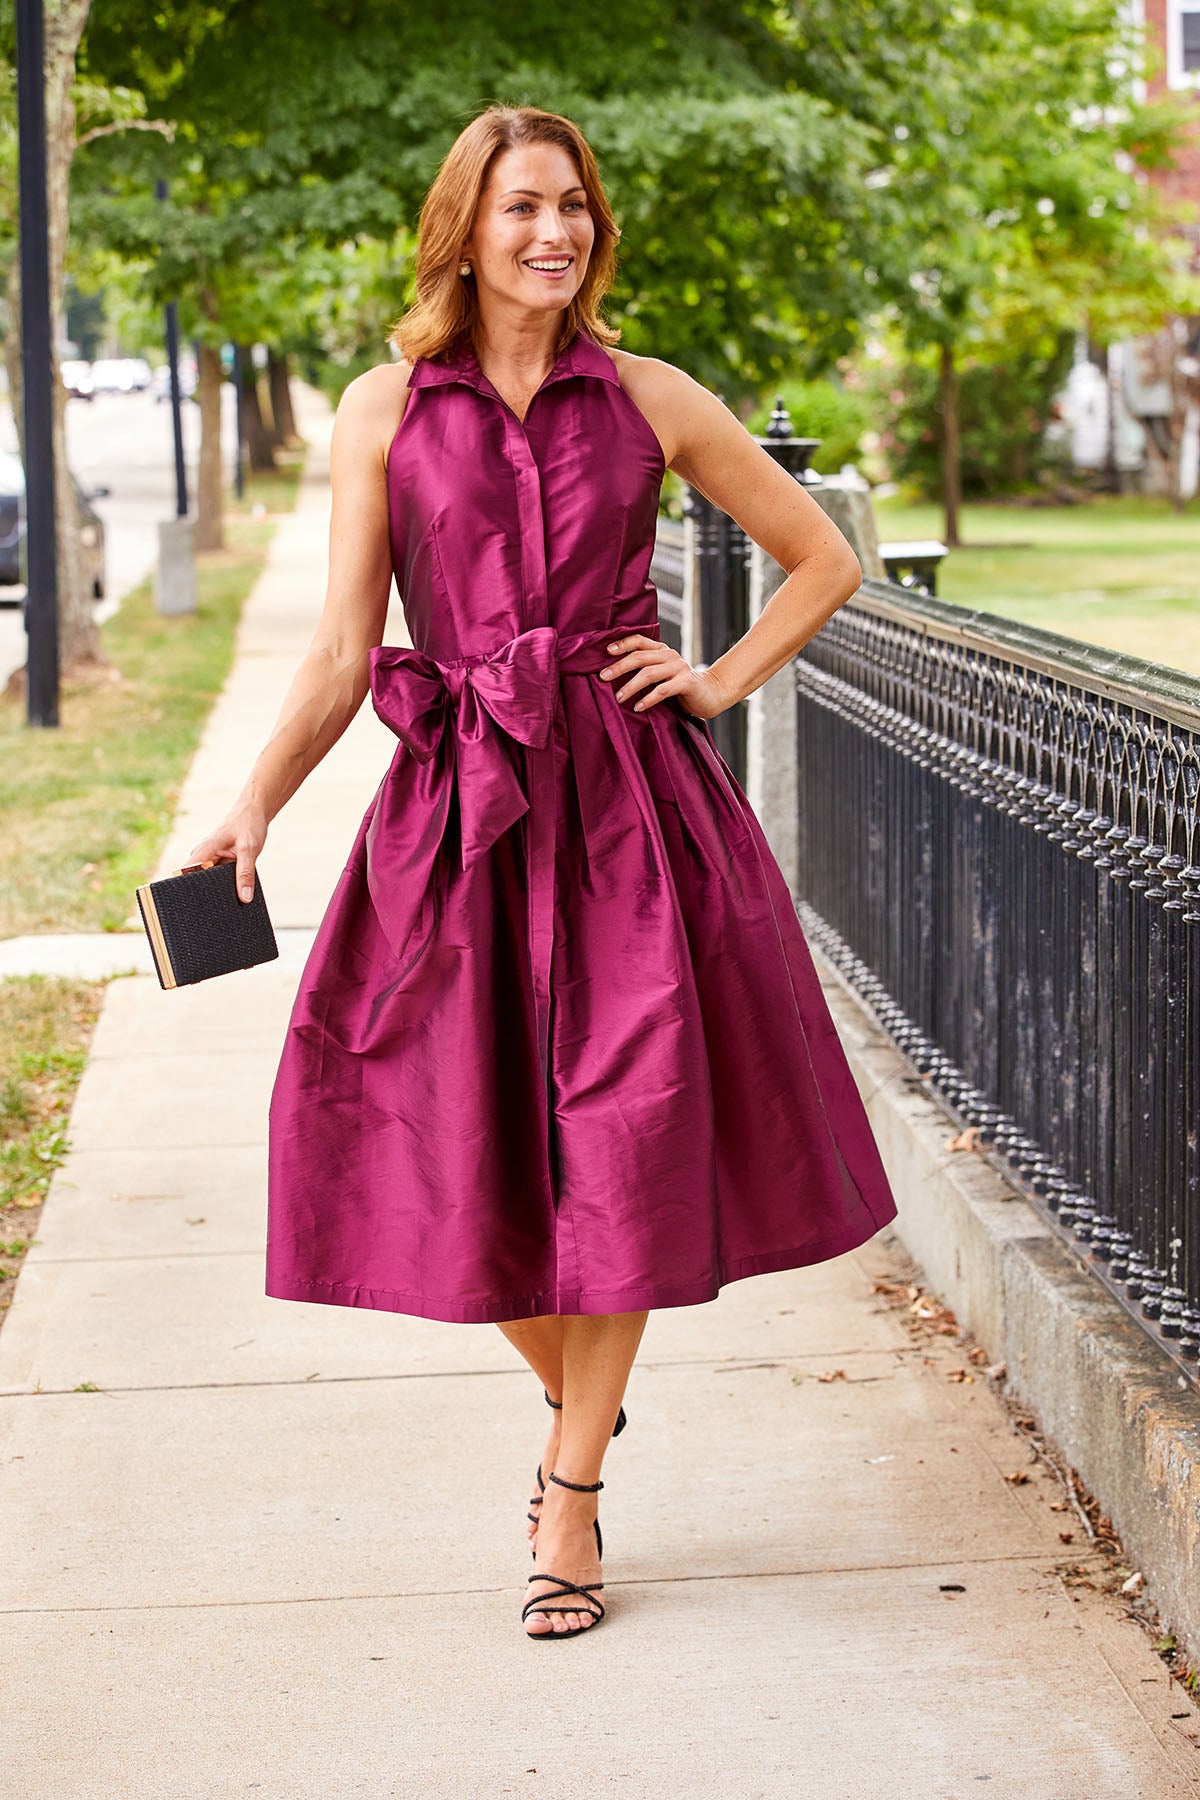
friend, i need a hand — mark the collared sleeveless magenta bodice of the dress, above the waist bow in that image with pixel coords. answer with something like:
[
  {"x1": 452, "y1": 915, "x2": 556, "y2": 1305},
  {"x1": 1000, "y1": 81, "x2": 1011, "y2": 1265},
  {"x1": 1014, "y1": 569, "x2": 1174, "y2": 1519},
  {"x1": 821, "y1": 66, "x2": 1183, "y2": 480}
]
[{"x1": 387, "y1": 331, "x2": 664, "y2": 661}]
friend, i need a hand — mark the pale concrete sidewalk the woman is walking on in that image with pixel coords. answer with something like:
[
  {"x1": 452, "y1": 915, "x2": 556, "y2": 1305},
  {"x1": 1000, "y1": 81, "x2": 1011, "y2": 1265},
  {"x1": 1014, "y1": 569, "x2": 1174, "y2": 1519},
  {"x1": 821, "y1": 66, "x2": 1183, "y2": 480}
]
[{"x1": 0, "y1": 397, "x2": 1200, "y2": 1800}]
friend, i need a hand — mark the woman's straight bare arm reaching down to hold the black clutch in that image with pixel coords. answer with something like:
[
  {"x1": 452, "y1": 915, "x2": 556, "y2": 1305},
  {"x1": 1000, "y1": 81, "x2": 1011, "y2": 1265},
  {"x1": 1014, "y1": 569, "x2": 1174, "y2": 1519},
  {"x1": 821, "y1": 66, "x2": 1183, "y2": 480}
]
[{"x1": 187, "y1": 364, "x2": 408, "y2": 900}]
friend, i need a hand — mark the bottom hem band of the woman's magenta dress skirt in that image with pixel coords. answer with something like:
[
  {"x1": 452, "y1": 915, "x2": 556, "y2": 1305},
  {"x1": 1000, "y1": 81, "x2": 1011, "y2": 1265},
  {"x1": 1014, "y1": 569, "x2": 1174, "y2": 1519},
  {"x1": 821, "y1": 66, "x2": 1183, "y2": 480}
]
[{"x1": 264, "y1": 1210, "x2": 896, "y2": 1325}]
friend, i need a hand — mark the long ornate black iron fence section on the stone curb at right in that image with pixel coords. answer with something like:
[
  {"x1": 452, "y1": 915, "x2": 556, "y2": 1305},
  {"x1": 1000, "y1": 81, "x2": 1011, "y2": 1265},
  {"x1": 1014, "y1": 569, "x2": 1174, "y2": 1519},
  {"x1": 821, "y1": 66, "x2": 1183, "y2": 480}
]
[{"x1": 793, "y1": 581, "x2": 1200, "y2": 1372}]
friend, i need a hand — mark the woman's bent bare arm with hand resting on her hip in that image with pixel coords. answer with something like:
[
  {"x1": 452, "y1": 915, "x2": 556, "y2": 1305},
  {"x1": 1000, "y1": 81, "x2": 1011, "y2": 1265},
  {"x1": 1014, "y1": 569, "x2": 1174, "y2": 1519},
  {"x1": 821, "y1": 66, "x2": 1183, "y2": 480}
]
[{"x1": 610, "y1": 356, "x2": 862, "y2": 716}]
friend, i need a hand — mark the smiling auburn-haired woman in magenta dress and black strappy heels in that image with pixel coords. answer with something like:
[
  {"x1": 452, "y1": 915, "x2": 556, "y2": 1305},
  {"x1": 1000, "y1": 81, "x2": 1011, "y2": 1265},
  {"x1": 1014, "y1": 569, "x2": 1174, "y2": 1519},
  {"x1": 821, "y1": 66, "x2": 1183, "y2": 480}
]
[{"x1": 191, "y1": 106, "x2": 896, "y2": 1640}]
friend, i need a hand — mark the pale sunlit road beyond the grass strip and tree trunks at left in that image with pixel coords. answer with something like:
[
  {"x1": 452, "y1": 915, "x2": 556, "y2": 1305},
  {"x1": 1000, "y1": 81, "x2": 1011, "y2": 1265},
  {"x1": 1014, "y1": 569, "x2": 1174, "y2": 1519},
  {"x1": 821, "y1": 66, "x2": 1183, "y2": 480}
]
[{"x1": 0, "y1": 383, "x2": 234, "y2": 684}]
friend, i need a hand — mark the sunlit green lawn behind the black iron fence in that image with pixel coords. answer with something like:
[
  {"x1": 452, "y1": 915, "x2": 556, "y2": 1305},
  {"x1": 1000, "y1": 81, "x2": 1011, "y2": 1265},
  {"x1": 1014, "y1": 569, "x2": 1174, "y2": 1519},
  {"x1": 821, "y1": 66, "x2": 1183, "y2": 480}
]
[{"x1": 874, "y1": 495, "x2": 1200, "y2": 677}]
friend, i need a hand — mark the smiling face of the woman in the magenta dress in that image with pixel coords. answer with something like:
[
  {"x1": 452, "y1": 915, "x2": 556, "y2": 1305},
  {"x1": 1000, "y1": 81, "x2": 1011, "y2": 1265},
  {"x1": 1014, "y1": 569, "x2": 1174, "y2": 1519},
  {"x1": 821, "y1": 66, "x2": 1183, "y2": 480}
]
[{"x1": 464, "y1": 144, "x2": 596, "y2": 324}]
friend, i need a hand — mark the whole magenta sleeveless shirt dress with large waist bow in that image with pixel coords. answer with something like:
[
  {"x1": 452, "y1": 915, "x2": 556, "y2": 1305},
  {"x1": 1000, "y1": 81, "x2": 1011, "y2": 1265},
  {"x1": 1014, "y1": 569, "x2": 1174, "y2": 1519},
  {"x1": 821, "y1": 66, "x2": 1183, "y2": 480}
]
[{"x1": 266, "y1": 333, "x2": 896, "y2": 1323}]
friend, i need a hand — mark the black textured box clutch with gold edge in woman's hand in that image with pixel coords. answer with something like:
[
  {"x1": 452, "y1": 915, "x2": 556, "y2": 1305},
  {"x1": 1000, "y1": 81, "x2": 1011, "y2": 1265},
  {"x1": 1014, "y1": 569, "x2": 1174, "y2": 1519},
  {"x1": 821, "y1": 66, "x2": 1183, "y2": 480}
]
[{"x1": 137, "y1": 862, "x2": 279, "y2": 988}]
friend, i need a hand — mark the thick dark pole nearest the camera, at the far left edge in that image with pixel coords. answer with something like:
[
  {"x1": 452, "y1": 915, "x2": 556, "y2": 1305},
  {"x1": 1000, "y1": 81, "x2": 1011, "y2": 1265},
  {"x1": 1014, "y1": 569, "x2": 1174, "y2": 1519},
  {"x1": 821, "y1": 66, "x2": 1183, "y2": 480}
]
[{"x1": 16, "y1": 0, "x2": 59, "y2": 725}]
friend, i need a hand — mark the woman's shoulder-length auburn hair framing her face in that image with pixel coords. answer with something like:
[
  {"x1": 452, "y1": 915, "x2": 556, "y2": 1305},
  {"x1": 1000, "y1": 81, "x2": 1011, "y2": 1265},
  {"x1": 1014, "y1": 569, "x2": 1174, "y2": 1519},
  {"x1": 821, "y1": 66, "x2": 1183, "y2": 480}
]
[{"x1": 389, "y1": 104, "x2": 621, "y2": 362}]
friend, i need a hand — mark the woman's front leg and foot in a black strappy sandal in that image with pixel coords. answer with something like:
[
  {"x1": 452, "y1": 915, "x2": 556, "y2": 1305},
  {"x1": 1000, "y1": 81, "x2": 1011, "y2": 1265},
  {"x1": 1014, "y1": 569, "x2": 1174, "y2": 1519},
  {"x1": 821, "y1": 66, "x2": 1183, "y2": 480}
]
[{"x1": 525, "y1": 1312, "x2": 649, "y2": 1636}]
